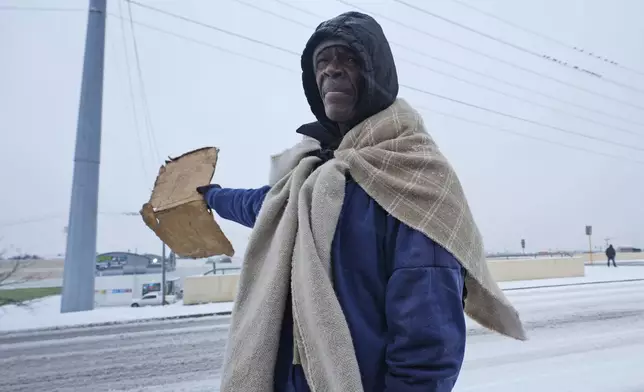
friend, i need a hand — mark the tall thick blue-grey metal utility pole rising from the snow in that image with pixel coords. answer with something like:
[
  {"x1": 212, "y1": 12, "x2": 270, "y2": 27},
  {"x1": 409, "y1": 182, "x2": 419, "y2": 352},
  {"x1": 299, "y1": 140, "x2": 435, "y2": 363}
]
[{"x1": 60, "y1": 0, "x2": 106, "y2": 313}]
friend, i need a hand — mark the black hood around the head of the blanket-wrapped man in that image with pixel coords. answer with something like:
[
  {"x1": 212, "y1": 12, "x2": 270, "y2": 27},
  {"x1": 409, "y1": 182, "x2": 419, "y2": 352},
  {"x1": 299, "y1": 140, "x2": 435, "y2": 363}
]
[{"x1": 298, "y1": 12, "x2": 398, "y2": 147}]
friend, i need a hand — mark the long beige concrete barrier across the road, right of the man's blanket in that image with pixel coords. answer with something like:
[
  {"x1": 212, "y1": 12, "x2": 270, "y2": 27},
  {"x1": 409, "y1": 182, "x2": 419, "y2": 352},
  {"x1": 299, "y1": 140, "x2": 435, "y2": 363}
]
[{"x1": 488, "y1": 257, "x2": 584, "y2": 282}]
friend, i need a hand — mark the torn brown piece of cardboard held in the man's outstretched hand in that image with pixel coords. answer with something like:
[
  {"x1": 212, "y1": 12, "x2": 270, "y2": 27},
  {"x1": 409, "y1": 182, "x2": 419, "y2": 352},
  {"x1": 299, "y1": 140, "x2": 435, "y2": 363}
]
[{"x1": 140, "y1": 147, "x2": 235, "y2": 259}]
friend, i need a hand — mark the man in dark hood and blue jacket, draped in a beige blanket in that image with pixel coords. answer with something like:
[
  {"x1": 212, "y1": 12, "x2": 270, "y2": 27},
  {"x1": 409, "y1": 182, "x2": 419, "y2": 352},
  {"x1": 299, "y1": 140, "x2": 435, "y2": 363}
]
[{"x1": 198, "y1": 12, "x2": 525, "y2": 392}]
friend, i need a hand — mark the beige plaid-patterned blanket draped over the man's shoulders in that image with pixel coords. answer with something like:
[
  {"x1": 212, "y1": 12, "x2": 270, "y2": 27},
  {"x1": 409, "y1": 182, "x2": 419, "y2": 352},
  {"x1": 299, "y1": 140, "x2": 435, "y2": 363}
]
[{"x1": 221, "y1": 99, "x2": 525, "y2": 392}]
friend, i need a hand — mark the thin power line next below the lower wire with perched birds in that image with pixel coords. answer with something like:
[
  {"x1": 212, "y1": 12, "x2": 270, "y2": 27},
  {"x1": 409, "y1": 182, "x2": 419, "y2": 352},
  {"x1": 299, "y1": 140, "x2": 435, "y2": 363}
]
[{"x1": 335, "y1": 0, "x2": 644, "y2": 110}]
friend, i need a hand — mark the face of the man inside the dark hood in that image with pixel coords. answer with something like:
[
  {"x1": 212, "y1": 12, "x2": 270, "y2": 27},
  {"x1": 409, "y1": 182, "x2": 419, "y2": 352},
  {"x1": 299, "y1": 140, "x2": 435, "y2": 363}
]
[{"x1": 313, "y1": 46, "x2": 362, "y2": 124}]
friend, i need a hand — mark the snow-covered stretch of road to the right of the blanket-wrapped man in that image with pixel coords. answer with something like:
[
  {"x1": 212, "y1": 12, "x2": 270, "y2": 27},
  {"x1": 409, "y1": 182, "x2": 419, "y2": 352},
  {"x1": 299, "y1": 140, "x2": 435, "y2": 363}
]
[{"x1": 455, "y1": 278, "x2": 644, "y2": 392}]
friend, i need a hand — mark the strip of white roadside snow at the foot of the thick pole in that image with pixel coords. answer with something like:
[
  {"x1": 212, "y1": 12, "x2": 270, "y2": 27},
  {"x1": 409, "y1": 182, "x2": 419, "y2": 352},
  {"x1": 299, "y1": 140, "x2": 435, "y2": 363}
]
[{"x1": 0, "y1": 295, "x2": 233, "y2": 331}]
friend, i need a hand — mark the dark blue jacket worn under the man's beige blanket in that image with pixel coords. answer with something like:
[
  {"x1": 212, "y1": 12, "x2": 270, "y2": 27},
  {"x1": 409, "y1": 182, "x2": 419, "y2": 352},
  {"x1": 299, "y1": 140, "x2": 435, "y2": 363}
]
[{"x1": 206, "y1": 178, "x2": 466, "y2": 392}]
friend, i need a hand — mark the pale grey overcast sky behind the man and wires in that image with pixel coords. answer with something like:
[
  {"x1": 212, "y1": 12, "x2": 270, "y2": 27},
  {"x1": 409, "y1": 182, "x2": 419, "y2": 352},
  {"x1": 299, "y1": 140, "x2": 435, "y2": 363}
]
[{"x1": 0, "y1": 0, "x2": 644, "y2": 256}]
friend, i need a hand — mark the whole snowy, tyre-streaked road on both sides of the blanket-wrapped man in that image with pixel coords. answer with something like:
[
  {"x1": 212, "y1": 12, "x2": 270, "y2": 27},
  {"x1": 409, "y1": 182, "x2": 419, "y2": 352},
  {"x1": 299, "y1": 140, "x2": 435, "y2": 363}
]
[{"x1": 0, "y1": 282, "x2": 644, "y2": 392}]
